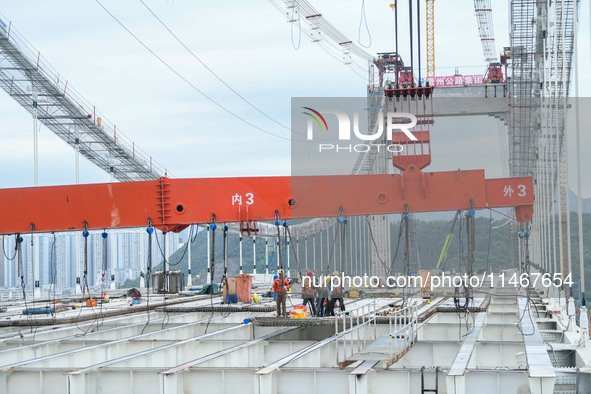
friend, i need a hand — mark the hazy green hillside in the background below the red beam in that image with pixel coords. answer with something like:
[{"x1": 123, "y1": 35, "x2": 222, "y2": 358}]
[{"x1": 124, "y1": 214, "x2": 591, "y2": 293}]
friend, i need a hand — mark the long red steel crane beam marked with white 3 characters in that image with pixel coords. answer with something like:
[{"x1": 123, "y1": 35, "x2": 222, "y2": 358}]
[{"x1": 0, "y1": 167, "x2": 534, "y2": 234}]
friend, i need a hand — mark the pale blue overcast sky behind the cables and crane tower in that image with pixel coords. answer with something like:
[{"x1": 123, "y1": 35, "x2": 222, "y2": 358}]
[{"x1": 0, "y1": 0, "x2": 591, "y2": 197}]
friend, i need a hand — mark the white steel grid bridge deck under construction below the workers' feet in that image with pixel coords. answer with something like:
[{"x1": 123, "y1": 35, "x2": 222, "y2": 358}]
[{"x1": 0, "y1": 272, "x2": 591, "y2": 394}]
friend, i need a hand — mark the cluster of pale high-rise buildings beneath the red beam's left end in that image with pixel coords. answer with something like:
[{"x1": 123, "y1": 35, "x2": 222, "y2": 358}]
[{"x1": 0, "y1": 229, "x2": 181, "y2": 297}]
